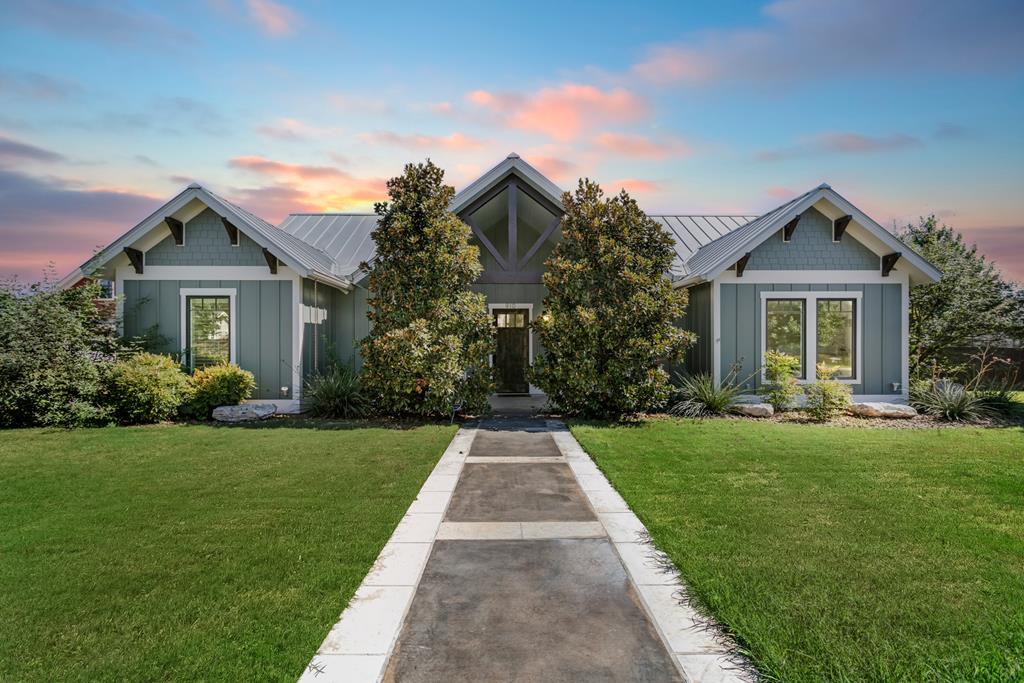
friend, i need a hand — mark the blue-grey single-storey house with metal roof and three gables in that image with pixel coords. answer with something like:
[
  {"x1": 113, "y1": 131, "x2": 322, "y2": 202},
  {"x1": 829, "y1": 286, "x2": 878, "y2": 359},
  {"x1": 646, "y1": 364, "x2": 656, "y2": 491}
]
[{"x1": 56, "y1": 155, "x2": 939, "y2": 410}]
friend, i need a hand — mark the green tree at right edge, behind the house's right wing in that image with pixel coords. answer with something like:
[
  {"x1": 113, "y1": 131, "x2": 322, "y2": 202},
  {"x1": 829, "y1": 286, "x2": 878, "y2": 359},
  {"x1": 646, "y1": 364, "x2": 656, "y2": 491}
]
[{"x1": 898, "y1": 216, "x2": 1024, "y2": 377}]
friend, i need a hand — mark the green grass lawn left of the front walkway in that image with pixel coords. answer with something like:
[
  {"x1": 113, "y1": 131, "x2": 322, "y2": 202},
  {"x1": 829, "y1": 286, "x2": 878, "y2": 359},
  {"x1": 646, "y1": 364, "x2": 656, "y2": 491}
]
[{"x1": 0, "y1": 422, "x2": 456, "y2": 681}]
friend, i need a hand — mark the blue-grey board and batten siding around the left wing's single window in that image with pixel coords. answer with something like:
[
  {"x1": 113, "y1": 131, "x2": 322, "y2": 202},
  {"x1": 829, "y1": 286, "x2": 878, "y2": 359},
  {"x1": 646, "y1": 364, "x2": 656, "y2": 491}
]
[{"x1": 122, "y1": 278, "x2": 295, "y2": 398}]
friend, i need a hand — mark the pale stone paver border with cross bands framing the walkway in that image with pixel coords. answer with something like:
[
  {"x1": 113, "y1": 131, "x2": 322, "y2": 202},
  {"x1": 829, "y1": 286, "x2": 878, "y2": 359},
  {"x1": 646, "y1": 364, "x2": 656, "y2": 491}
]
[{"x1": 299, "y1": 421, "x2": 752, "y2": 683}]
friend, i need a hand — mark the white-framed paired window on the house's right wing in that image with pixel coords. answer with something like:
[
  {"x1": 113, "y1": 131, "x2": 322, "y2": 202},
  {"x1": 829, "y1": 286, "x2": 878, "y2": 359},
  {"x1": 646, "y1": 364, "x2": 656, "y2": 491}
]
[{"x1": 761, "y1": 292, "x2": 860, "y2": 384}]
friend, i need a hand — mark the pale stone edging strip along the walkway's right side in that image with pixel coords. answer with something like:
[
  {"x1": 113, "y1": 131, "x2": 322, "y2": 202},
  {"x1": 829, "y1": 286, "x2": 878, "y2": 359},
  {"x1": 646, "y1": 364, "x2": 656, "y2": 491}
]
[{"x1": 548, "y1": 421, "x2": 754, "y2": 683}]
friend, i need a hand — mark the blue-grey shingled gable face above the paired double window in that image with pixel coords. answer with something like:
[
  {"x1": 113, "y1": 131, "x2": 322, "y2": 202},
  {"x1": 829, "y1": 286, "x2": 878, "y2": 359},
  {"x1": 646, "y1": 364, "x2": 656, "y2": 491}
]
[{"x1": 746, "y1": 207, "x2": 880, "y2": 270}]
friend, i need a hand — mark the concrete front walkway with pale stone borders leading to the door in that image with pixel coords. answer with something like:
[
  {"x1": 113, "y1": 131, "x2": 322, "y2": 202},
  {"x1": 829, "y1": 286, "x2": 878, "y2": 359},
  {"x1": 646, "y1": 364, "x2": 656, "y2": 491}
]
[{"x1": 301, "y1": 419, "x2": 739, "y2": 683}]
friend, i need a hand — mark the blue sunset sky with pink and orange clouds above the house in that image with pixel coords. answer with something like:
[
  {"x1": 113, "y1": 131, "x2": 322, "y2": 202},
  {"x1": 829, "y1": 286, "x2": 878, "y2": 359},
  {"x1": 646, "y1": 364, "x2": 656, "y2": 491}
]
[{"x1": 0, "y1": 0, "x2": 1024, "y2": 282}]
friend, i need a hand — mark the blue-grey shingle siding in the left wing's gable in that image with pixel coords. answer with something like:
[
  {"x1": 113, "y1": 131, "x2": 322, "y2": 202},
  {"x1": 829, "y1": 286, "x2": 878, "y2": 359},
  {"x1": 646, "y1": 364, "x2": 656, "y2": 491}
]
[{"x1": 145, "y1": 209, "x2": 266, "y2": 265}]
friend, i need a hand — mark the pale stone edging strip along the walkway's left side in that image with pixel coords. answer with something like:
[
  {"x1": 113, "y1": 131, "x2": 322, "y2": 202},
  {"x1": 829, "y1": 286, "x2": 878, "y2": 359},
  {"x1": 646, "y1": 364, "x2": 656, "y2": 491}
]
[{"x1": 299, "y1": 428, "x2": 477, "y2": 683}]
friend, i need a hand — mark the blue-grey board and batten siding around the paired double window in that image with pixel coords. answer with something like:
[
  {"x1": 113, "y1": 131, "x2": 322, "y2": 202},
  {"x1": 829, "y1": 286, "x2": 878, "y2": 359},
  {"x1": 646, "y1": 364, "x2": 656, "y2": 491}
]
[{"x1": 720, "y1": 282, "x2": 904, "y2": 395}]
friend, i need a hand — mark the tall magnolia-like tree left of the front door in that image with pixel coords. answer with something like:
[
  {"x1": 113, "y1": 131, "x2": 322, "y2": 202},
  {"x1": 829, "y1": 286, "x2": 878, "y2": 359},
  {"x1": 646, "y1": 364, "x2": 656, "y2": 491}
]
[{"x1": 362, "y1": 160, "x2": 494, "y2": 415}]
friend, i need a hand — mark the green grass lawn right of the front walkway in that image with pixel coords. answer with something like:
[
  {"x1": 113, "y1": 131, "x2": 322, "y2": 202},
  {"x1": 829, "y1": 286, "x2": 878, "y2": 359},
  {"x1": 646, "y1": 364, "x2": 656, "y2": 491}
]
[{"x1": 572, "y1": 420, "x2": 1024, "y2": 681}]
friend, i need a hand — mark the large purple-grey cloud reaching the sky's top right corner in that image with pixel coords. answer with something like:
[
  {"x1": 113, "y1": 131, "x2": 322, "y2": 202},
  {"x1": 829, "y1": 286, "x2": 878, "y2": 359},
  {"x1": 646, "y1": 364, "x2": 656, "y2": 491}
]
[{"x1": 631, "y1": 0, "x2": 1024, "y2": 88}]
